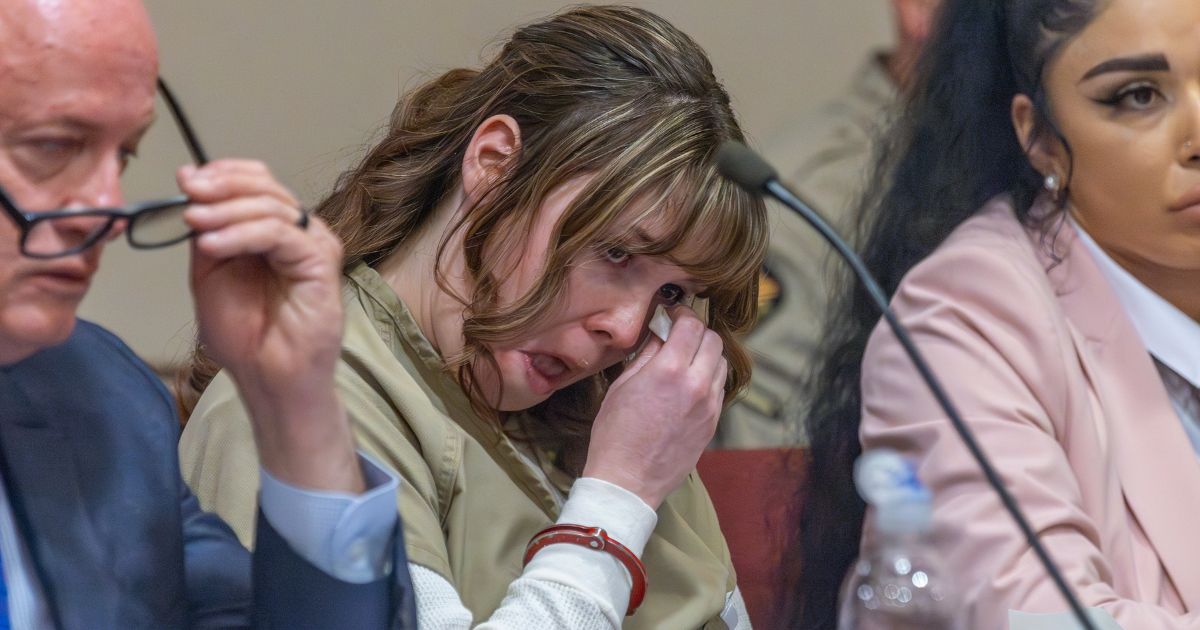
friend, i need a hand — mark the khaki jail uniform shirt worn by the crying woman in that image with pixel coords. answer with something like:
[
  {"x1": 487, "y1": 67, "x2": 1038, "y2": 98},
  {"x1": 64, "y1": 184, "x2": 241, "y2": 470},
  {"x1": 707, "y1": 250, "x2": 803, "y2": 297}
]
[{"x1": 180, "y1": 265, "x2": 736, "y2": 629}]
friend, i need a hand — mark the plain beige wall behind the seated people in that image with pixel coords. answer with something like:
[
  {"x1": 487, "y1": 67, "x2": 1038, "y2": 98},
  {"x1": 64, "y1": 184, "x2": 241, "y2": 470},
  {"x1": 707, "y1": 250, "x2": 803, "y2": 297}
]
[{"x1": 82, "y1": 0, "x2": 890, "y2": 365}]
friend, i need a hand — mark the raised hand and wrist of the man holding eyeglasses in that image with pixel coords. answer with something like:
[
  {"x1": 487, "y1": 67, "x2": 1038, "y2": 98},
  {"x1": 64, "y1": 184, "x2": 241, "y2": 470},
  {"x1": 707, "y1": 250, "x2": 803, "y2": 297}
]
[{"x1": 178, "y1": 160, "x2": 364, "y2": 493}]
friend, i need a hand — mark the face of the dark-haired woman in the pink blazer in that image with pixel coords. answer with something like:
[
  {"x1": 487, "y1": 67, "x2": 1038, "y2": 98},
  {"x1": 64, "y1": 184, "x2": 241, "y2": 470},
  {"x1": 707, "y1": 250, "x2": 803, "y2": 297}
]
[{"x1": 1045, "y1": 0, "x2": 1200, "y2": 277}]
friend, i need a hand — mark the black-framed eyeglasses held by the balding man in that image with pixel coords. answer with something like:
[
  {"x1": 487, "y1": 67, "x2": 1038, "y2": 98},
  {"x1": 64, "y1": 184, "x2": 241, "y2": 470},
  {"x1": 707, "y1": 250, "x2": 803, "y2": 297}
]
[{"x1": 0, "y1": 77, "x2": 211, "y2": 259}]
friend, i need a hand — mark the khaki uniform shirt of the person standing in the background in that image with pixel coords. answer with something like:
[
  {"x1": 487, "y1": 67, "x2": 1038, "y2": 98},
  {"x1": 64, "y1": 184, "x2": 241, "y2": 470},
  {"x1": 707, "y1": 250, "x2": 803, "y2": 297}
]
[{"x1": 714, "y1": 55, "x2": 895, "y2": 449}]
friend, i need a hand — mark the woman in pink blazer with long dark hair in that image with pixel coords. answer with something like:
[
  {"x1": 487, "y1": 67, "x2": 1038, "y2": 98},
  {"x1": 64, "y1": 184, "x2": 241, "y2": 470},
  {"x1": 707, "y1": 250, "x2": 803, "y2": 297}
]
[{"x1": 797, "y1": 0, "x2": 1200, "y2": 630}]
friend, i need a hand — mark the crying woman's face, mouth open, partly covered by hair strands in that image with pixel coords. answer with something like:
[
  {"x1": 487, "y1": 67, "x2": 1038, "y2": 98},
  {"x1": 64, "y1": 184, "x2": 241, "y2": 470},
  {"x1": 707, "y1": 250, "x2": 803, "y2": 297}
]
[{"x1": 480, "y1": 178, "x2": 703, "y2": 412}]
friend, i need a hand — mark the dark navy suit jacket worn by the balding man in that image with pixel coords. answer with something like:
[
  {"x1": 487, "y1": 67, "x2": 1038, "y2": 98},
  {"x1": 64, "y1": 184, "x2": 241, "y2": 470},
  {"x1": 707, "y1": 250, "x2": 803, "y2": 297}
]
[{"x1": 0, "y1": 322, "x2": 416, "y2": 630}]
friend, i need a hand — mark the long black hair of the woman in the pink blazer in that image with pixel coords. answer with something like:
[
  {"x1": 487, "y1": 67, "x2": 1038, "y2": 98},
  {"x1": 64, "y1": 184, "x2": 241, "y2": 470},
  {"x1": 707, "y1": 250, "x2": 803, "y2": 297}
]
[{"x1": 792, "y1": 0, "x2": 1104, "y2": 629}]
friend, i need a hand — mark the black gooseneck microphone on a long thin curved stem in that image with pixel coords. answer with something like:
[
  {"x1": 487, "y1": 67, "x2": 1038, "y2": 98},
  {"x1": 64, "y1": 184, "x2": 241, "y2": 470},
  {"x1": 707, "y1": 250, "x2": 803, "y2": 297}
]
[{"x1": 716, "y1": 140, "x2": 1097, "y2": 630}]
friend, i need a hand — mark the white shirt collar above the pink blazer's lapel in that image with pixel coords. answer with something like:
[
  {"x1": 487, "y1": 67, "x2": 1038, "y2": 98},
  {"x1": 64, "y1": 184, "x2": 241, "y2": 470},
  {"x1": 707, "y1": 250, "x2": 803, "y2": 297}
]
[{"x1": 1072, "y1": 220, "x2": 1200, "y2": 388}]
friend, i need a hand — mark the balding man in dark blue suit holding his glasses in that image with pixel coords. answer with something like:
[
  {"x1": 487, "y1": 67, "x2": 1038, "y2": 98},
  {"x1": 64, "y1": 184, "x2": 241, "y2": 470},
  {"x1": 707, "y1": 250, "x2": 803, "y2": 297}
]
[{"x1": 0, "y1": 0, "x2": 415, "y2": 629}]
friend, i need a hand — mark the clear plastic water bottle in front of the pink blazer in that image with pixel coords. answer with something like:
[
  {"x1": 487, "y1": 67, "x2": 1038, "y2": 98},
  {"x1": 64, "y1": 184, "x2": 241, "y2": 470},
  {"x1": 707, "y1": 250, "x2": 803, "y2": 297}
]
[{"x1": 838, "y1": 449, "x2": 960, "y2": 630}]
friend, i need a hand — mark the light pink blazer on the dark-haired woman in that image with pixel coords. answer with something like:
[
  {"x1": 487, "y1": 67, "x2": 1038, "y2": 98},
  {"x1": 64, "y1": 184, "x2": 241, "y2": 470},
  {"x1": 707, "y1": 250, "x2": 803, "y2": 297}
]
[{"x1": 862, "y1": 195, "x2": 1200, "y2": 630}]
